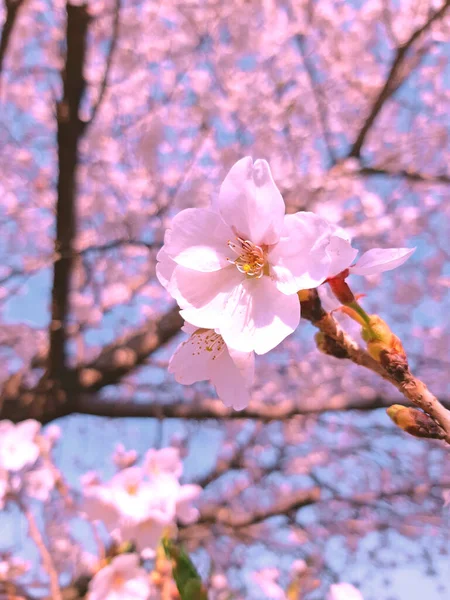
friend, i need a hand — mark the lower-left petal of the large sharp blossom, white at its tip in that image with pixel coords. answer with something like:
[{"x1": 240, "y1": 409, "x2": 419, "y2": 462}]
[{"x1": 173, "y1": 265, "x2": 245, "y2": 329}]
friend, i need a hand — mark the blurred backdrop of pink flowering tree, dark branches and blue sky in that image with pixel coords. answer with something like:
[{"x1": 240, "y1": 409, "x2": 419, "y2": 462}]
[{"x1": 0, "y1": 0, "x2": 450, "y2": 600}]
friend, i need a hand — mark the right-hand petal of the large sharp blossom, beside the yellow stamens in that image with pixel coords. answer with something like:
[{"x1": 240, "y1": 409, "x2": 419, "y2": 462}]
[{"x1": 269, "y1": 212, "x2": 330, "y2": 294}]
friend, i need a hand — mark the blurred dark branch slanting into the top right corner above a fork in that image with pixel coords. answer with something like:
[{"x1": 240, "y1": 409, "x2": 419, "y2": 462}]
[{"x1": 348, "y1": 0, "x2": 450, "y2": 158}]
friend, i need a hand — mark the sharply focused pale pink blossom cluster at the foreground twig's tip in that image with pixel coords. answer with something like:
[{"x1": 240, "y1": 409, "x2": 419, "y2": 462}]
[{"x1": 157, "y1": 157, "x2": 414, "y2": 410}]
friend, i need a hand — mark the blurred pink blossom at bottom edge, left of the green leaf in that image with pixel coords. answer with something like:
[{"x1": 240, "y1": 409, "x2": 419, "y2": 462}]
[{"x1": 87, "y1": 554, "x2": 153, "y2": 600}]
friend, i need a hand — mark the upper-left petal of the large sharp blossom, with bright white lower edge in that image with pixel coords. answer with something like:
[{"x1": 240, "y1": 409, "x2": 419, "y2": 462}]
[{"x1": 164, "y1": 208, "x2": 234, "y2": 272}]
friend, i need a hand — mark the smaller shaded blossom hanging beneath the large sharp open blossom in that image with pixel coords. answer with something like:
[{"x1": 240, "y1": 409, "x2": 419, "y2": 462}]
[{"x1": 169, "y1": 326, "x2": 253, "y2": 410}]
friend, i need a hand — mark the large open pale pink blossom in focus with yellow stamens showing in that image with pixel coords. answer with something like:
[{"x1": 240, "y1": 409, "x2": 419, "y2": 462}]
[{"x1": 157, "y1": 157, "x2": 348, "y2": 354}]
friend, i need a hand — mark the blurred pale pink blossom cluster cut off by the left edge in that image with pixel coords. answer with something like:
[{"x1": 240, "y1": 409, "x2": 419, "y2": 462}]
[{"x1": 0, "y1": 419, "x2": 60, "y2": 509}]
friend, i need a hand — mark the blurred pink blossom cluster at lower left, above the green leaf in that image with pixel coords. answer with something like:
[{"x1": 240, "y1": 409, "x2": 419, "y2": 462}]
[{"x1": 82, "y1": 448, "x2": 201, "y2": 557}]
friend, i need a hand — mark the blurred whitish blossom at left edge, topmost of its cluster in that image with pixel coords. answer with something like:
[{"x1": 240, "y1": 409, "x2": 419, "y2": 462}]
[{"x1": 0, "y1": 419, "x2": 41, "y2": 471}]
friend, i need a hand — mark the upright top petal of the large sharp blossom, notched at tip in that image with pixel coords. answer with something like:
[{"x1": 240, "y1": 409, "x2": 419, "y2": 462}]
[{"x1": 217, "y1": 156, "x2": 285, "y2": 245}]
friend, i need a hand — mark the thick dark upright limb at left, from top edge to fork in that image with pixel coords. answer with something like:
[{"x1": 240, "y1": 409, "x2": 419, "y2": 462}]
[{"x1": 48, "y1": 3, "x2": 90, "y2": 381}]
